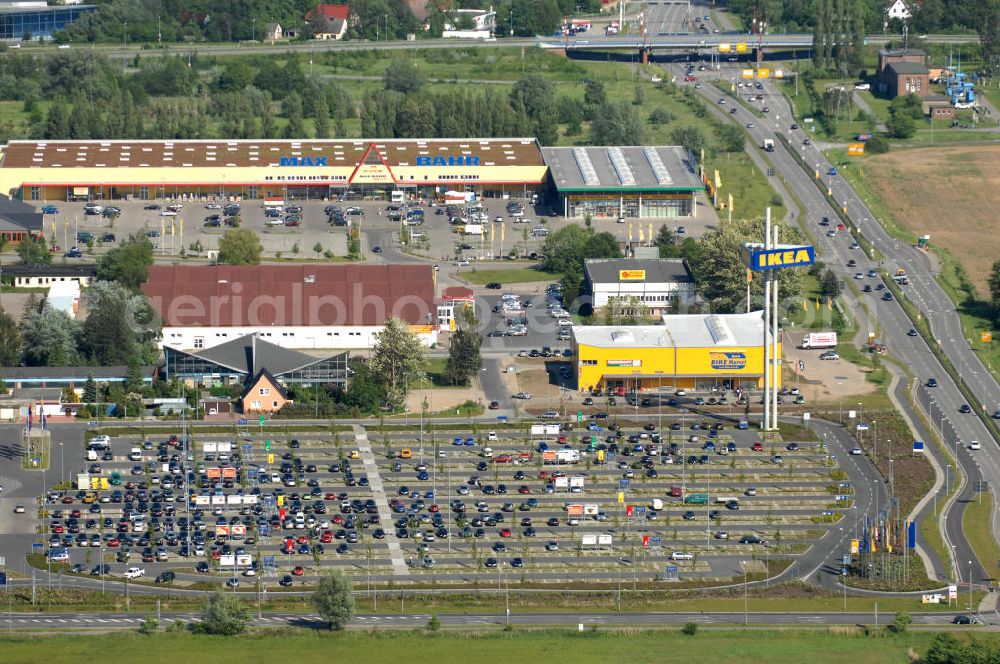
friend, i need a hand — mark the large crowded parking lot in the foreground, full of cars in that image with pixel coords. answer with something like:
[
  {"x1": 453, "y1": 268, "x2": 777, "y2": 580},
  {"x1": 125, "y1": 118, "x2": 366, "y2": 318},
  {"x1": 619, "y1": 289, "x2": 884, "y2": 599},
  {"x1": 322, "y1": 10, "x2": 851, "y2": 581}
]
[{"x1": 35, "y1": 413, "x2": 851, "y2": 587}]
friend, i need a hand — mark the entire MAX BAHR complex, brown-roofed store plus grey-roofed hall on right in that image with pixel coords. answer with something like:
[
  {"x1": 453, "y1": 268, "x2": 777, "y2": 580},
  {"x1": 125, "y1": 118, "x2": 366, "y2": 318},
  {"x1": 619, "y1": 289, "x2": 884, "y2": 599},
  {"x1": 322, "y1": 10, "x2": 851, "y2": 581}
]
[{"x1": 0, "y1": 138, "x2": 703, "y2": 211}]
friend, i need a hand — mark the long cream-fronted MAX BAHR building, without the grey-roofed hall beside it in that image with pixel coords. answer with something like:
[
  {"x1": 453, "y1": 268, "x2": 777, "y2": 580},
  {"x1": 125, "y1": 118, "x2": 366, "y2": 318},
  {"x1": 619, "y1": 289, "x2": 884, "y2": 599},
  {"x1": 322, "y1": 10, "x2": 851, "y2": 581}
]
[{"x1": 0, "y1": 138, "x2": 546, "y2": 201}]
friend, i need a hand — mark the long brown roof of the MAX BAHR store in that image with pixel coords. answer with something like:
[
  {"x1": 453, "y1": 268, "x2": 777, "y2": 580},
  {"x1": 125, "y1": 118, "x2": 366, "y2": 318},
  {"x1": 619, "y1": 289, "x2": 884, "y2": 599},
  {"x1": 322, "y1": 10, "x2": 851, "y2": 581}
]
[{"x1": 0, "y1": 138, "x2": 544, "y2": 168}]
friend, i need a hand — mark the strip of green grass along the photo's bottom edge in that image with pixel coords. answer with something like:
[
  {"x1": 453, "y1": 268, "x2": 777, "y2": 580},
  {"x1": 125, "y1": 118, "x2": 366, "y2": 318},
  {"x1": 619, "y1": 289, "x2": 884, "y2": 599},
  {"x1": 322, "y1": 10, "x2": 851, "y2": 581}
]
[{"x1": 0, "y1": 627, "x2": 998, "y2": 664}]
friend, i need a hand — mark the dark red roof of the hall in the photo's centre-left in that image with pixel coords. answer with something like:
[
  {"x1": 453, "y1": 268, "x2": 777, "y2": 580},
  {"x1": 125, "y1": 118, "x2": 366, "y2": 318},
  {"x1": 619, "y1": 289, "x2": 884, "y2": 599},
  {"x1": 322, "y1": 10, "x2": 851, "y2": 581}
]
[{"x1": 142, "y1": 264, "x2": 436, "y2": 327}]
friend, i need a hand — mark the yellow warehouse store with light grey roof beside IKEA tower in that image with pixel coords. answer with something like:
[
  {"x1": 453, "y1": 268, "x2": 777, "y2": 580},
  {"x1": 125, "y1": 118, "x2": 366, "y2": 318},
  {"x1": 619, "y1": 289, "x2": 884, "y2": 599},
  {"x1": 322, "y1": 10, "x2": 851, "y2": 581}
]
[{"x1": 572, "y1": 311, "x2": 780, "y2": 393}]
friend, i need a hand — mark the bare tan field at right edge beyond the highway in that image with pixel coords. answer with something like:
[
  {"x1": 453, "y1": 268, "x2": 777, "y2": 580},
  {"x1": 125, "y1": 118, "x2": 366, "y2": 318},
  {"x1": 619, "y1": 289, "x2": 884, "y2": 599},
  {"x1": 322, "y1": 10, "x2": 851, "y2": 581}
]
[{"x1": 865, "y1": 146, "x2": 1000, "y2": 294}]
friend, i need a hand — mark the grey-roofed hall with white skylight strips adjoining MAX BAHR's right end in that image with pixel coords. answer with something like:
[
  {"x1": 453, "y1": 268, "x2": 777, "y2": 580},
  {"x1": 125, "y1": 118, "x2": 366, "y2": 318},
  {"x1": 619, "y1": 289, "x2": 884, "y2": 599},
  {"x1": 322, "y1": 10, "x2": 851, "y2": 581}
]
[{"x1": 542, "y1": 146, "x2": 705, "y2": 219}]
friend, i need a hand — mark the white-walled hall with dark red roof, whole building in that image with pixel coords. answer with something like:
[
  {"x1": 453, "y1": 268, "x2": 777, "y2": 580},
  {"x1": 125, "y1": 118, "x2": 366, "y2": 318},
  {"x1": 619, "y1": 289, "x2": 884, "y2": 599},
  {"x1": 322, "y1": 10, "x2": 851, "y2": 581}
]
[{"x1": 142, "y1": 264, "x2": 438, "y2": 350}]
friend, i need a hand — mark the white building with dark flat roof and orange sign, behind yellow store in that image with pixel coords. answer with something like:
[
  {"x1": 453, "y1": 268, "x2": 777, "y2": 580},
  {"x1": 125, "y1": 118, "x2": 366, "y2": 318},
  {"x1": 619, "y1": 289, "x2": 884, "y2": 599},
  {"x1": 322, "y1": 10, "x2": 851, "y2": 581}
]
[{"x1": 583, "y1": 258, "x2": 695, "y2": 316}]
